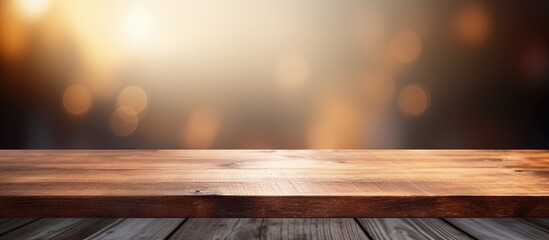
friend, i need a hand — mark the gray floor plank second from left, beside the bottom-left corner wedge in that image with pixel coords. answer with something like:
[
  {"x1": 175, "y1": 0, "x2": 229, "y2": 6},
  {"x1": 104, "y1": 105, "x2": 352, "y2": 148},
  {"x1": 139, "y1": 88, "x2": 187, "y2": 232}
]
[{"x1": 0, "y1": 218, "x2": 116, "y2": 240}]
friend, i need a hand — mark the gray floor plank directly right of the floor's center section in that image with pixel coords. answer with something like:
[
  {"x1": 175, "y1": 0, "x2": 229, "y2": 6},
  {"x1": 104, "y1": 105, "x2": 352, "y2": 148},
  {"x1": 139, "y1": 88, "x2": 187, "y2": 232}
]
[{"x1": 358, "y1": 218, "x2": 472, "y2": 240}]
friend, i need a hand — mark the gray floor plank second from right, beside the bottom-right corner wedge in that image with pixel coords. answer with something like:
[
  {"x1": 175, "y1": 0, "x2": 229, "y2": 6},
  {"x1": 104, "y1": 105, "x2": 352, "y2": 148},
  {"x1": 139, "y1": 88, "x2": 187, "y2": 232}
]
[{"x1": 447, "y1": 218, "x2": 549, "y2": 240}]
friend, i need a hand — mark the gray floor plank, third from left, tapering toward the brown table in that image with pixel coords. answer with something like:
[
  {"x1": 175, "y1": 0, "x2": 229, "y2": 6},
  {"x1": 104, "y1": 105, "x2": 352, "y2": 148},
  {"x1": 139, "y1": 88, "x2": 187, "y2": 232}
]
[{"x1": 86, "y1": 218, "x2": 184, "y2": 240}]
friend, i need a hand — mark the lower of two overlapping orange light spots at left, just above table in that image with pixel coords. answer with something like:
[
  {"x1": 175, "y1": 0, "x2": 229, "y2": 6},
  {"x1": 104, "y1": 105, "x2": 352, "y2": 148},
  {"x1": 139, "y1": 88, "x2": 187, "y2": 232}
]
[{"x1": 111, "y1": 107, "x2": 139, "y2": 137}]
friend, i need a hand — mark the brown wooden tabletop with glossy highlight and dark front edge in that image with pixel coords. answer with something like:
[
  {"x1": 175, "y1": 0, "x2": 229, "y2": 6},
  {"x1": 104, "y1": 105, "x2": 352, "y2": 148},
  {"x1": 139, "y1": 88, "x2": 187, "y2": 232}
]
[{"x1": 0, "y1": 150, "x2": 549, "y2": 217}]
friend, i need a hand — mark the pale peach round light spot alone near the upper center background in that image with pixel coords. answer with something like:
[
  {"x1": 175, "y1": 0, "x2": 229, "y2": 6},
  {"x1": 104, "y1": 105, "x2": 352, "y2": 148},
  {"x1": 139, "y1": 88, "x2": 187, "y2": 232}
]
[{"x1": 276, "y1": 54, "x2": 310, "y2": 90}]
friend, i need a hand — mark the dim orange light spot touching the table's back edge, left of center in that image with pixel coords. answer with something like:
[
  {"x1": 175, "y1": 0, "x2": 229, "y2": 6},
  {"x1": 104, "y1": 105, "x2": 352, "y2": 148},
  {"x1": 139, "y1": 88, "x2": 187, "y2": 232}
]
[{"x1": 184, "y1": 108, "x2": 221, "y2": 148}]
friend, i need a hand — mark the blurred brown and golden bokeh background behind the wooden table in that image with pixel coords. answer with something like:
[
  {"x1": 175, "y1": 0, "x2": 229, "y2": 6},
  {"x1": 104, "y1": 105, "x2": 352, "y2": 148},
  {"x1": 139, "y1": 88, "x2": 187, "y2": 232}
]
[{"x1": 0, "y1": 0, "x2": 549, "y2": 149}]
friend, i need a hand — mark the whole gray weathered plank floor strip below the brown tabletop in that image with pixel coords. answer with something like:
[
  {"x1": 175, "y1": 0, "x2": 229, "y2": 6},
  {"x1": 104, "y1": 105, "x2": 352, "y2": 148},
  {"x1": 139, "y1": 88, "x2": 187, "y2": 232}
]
[{"x1": 0, "y1": 218, "x2": 549, "y2": 240}]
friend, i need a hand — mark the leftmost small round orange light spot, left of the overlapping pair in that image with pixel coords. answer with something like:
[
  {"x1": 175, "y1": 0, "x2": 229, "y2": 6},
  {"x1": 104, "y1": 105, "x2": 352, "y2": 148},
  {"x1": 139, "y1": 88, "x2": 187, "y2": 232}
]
[{"x1": 63, "y1": 85, "x2": 92, "y2": 115}]
